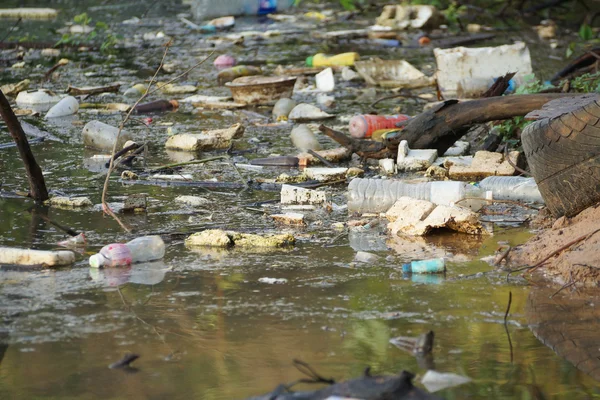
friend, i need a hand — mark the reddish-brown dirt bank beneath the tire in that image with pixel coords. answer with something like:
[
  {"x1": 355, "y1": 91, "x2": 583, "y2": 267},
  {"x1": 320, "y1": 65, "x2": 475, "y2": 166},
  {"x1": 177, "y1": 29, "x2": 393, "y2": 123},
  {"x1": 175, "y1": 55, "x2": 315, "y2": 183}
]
[{"x1": 509, "y1": 204, "x2": 600, "y2": 286}]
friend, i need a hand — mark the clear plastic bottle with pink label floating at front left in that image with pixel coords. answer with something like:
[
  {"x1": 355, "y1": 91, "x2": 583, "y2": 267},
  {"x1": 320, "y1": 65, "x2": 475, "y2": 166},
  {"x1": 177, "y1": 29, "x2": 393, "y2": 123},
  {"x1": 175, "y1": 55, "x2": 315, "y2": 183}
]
[{"x1": 89, "y1": 236, "x2": 165, "y2": 268}]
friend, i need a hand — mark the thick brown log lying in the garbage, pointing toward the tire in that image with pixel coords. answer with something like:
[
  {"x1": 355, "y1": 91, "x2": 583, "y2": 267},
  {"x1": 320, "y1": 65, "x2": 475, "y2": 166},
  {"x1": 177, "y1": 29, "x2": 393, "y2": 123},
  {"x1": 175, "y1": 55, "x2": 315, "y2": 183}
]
[{"x1": 384, "y1": 93, "x2": 573, "y2": 154}]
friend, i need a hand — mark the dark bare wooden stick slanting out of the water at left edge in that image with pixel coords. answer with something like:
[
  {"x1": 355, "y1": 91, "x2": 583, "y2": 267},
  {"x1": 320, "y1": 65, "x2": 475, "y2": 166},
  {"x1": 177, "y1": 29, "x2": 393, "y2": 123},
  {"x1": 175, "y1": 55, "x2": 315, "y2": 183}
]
[{"x1": 0, "y1": 90, "x2": 48, "y2": 203}]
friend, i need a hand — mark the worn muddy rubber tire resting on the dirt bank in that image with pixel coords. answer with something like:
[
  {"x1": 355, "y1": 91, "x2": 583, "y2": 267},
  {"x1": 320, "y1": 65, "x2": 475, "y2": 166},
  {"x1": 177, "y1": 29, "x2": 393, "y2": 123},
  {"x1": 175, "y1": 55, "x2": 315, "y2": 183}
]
[{"x1": 521, "y1": 95, "x2": 600, "y2": 217}]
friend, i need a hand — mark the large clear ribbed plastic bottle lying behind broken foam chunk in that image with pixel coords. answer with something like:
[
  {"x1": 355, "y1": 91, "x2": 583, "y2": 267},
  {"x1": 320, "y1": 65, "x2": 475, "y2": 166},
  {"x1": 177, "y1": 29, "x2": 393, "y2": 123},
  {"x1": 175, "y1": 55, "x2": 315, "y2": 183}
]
[{"x1": 348, "y1": 178, "x2": 485, "y2": 213}]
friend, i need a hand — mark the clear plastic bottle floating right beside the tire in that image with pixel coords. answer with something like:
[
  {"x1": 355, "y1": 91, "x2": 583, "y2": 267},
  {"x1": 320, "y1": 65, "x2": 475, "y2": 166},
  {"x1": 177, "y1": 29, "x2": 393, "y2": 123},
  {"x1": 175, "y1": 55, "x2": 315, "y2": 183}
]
[{"x1": 478, "y1": 176, "x2": 544, "y2": 203}]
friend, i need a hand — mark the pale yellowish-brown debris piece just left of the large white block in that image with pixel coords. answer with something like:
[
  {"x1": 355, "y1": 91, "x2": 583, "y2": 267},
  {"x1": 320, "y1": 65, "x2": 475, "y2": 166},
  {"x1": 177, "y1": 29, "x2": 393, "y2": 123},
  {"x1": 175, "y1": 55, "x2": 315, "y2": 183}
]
[{"x1": 355, "y1": 58, "x2": 435, "y2": 89}]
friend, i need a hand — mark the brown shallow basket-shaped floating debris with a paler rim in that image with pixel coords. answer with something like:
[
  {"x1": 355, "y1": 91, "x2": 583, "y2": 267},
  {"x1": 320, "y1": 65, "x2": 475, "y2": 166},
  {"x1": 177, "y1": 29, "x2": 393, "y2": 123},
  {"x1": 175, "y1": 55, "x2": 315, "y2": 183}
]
[{"x1": 225, "y1": 75, "x2": 296, "y2": 104}]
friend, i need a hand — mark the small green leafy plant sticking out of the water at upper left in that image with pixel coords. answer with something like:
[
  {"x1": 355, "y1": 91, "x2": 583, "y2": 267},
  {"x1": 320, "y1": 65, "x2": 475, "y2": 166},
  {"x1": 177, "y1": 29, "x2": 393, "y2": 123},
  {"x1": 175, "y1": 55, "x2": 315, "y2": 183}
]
[{"x1": 56, "y1": 13, "x2": 122, "y2": 53}]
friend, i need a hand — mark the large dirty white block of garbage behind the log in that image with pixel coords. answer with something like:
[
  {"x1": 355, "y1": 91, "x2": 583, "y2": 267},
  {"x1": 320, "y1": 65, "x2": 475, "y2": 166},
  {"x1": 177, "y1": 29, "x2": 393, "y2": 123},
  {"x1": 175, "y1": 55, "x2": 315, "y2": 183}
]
[{"x1": 433, "y1": 42, "x2": 532, "y2": 99}]
